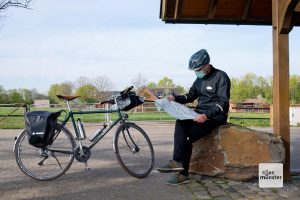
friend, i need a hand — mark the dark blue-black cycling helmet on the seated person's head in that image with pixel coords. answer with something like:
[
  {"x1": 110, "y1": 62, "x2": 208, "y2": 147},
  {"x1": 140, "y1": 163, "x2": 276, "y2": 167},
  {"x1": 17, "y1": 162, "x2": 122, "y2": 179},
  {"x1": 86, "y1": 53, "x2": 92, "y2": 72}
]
[{"x1": 189, "y1": 49, "x2": 210, "y2": 70}]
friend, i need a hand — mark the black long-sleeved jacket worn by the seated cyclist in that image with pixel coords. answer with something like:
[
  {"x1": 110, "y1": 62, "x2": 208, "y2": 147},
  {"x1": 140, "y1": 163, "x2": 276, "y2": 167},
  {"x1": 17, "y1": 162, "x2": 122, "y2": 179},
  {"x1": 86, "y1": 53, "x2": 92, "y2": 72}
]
[{"x1": 175, "y1": 67, "x2": 230, "y2": 123}]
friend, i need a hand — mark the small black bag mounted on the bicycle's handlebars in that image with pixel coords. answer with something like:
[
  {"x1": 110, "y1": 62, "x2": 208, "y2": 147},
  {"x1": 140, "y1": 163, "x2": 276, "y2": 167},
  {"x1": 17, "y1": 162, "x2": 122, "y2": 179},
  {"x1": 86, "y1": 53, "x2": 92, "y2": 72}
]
[{"x1": 119, "y1": 92, "x2": 145, "y2": 111}]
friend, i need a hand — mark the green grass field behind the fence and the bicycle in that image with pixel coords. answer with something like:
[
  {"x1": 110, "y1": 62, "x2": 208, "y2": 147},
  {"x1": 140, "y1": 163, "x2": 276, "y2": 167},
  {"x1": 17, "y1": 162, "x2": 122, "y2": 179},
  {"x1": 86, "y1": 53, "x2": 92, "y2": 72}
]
[{"x1": 0, "y1": 107, "x2": 270, "y2": 129}]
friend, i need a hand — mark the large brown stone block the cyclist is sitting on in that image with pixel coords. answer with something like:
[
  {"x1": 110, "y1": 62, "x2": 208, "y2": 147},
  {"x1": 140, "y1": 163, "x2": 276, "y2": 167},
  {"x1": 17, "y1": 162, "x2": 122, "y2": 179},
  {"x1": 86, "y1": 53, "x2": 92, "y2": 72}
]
[{"x1": 190, "y1": 124, "x2": 285, "y2": 181}]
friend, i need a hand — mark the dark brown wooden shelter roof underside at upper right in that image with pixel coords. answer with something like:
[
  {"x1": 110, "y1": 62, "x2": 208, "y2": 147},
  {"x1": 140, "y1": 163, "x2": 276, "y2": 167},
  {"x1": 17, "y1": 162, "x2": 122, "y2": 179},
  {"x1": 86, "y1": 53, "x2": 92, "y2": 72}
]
[{"x1": 160, "y1": 0, "x2": 300, "y2": 26}]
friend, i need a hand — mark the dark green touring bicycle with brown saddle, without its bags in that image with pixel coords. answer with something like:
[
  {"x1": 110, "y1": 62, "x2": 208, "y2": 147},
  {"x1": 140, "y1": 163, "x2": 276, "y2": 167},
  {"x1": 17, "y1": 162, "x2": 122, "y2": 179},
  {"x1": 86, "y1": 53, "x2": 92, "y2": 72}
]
[{"x1": 14, "y1": 86, "x2": 154, "y2": 180}]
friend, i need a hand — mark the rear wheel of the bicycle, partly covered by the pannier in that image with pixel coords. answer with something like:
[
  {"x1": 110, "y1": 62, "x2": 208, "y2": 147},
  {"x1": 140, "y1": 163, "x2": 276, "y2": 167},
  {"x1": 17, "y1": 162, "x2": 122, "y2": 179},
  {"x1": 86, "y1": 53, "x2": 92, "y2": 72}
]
[{"x1": 14, "y1": 124, "x2": 76, "y2": 181}]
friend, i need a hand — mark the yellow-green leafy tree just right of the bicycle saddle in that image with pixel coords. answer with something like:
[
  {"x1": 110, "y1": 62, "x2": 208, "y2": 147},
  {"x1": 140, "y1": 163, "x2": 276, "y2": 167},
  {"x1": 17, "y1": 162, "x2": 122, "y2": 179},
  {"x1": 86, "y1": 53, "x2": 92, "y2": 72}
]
[{"x1": 76, "y1": 84, "x2": 97, "y2": 103}]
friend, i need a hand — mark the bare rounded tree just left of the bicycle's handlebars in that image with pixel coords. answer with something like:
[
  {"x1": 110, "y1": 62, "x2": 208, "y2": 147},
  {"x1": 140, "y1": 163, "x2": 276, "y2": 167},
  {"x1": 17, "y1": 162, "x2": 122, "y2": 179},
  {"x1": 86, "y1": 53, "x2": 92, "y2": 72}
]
[{"x1": 93, "y1": 76, "x2": 114, "y2": 101}]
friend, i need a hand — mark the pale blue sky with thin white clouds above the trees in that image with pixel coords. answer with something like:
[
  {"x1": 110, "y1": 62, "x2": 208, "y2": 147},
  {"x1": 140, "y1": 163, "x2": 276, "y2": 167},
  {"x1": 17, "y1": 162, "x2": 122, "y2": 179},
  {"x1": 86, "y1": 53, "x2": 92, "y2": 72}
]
[{"x1": 0, "y1": 0, "x2": 300, "y2": 94}]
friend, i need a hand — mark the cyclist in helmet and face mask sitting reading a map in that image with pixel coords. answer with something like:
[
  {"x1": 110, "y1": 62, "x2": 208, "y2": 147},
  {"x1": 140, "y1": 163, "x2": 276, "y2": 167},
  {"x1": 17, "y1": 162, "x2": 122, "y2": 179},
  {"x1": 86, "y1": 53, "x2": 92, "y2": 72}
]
[{"x1": 157, "y1": 49, "x2": 230, "y2": 185}]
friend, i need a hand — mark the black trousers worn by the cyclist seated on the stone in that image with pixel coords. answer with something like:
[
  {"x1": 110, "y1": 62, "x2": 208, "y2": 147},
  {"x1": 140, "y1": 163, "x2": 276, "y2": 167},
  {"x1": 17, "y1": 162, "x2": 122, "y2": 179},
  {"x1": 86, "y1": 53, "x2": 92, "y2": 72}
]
[{"x1": 173, "y1": 120, "x2": 225, "y2": 174}]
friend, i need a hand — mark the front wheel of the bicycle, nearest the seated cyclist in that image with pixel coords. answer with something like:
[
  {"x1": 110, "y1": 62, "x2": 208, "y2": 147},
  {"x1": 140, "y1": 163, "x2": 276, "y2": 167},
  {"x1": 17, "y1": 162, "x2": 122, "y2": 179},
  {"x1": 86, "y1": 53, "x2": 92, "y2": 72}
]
[{"x1": 114, "y1": 123, "x2": 154, "y2": 178}]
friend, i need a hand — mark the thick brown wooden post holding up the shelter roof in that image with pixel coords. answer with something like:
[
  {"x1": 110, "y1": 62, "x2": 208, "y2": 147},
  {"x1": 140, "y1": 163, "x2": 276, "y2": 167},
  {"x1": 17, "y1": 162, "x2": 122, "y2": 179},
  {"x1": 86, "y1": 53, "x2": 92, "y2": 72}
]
[{"x1": 272, "y1": 0, "x2": 290, "y2": 180}]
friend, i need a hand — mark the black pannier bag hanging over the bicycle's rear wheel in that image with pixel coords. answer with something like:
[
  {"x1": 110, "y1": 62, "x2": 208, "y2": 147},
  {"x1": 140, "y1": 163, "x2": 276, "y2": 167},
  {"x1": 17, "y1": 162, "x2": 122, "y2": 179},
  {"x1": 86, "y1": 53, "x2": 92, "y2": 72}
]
[{"x1": 24, "y1": 111, "x2": 60, "y2": 148}]
